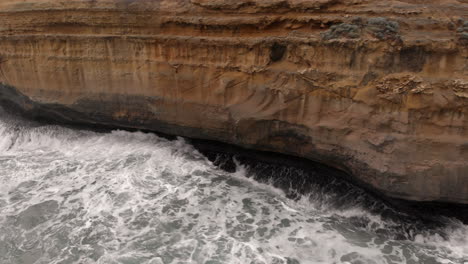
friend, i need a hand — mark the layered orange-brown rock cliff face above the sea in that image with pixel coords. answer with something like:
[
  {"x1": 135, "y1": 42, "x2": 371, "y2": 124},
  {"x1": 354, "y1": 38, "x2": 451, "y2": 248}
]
[{"x1": 0, "y1": 0, "x2": 468, "y2": 204}]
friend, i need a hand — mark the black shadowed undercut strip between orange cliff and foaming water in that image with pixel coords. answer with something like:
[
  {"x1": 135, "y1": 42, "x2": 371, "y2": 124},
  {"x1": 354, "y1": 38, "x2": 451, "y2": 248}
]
[{"x1": 0, "y1": 87, "x2": 468, "y2": 225}]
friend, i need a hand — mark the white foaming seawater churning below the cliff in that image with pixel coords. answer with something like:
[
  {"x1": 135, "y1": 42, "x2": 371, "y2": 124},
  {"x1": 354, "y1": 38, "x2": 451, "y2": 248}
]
[{"x1": 0, "y1": 114, "x2": 468, "y2": 264}]
